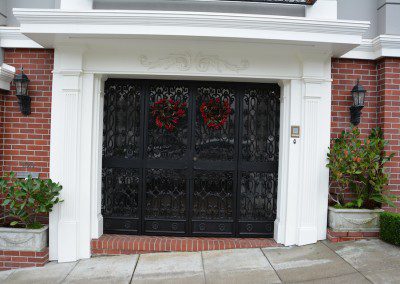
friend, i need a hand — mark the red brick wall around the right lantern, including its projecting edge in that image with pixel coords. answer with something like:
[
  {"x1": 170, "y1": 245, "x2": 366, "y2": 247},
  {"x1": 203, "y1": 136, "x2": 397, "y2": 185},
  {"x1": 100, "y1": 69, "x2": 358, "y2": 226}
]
[{"x1": 331, "y1": 58, "x2": 400, "y2": 212}]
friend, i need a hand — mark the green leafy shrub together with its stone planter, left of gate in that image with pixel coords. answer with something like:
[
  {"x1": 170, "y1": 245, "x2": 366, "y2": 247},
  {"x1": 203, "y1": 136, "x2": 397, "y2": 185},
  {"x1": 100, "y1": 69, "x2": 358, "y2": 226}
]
[{"x1": 0, "y1": 173, "x2": 62, "y2": 251}]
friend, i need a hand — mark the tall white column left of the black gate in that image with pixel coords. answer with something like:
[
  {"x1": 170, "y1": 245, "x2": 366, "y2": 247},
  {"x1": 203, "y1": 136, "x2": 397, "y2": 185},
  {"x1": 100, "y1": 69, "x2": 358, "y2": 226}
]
[{"x1": 49, "y1": 47, "x2": 93, "y2": 262}]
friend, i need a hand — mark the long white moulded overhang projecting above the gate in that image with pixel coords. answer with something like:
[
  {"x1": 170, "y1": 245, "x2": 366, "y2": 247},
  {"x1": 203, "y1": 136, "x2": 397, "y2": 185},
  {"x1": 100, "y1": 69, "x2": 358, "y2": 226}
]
[{"x1": 14, "y1": 9, "x2": 369, "y2": 56}]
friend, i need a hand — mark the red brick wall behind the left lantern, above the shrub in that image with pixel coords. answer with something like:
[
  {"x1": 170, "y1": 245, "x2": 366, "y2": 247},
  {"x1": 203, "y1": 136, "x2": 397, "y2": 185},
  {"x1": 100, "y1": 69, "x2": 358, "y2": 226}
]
[{"x1": 1, "y1": 49, "x2": 54, "y2": 178}]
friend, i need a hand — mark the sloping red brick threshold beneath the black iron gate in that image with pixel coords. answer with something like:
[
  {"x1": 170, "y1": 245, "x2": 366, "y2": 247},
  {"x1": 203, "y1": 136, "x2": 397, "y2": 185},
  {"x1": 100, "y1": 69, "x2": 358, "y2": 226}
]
[{"x1": 91, "y1": 234, "x2": 281, "y2": 255}]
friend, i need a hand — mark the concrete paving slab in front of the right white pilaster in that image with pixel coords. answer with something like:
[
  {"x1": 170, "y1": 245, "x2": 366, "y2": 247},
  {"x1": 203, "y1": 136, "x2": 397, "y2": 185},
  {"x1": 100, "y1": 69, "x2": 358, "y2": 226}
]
[{"x1": 263, "y1": 243, "x2": 357, "y2": 282}]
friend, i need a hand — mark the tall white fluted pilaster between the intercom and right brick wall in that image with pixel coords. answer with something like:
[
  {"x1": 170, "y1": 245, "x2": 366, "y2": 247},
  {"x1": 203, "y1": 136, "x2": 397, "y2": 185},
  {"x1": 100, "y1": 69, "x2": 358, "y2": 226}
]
[{"x1": 297, "y1": 54, "x2": 331, "y2": 245}]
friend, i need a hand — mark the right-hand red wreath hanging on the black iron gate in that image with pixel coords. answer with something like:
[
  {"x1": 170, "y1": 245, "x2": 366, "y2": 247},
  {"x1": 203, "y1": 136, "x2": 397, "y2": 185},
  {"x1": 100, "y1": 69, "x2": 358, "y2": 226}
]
[{"x1": 200, "y1": 98, "x2": 232, "y2": 129}]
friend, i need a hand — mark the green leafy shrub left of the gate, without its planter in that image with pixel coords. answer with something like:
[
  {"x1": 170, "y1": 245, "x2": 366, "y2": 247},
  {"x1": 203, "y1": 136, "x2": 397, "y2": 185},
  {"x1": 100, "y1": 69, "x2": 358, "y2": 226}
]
[{"x1": 0, "y1": 173, "x2": 62, "y2": 229}]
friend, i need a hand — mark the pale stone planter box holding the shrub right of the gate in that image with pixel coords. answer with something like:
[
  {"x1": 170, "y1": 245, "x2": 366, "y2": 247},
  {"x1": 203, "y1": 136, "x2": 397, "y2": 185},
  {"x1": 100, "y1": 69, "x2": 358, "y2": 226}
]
[{"x1": 328, "y1": 207, "x2": 383, "y2": 232}]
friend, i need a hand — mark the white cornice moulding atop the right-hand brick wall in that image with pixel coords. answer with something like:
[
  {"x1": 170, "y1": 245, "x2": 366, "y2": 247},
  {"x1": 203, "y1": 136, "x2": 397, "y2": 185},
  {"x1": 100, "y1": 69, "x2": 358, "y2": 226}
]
[{"x1": 342, "y1": 35, "x2": 400, "y2": 60}]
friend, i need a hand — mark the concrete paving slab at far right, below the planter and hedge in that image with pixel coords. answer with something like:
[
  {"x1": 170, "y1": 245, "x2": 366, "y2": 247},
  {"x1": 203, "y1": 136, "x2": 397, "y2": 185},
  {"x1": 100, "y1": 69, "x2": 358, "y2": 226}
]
[{"x1": 326, "y1": 239, "x2": 400, "y2": 273}]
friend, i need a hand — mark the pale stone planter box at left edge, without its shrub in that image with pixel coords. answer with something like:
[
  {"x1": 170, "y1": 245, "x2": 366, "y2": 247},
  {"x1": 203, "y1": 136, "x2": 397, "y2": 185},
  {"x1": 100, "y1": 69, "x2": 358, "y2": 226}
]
[{"x1": 0, "y1": 226, "x2": 49, "y2": 251}]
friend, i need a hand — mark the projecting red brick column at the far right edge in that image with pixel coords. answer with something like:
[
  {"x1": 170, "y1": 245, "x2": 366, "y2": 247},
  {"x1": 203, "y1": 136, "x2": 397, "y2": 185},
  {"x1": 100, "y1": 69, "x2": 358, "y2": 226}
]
[{"x1": 377, "y1": 58, "x2": 400, "y2": 212}]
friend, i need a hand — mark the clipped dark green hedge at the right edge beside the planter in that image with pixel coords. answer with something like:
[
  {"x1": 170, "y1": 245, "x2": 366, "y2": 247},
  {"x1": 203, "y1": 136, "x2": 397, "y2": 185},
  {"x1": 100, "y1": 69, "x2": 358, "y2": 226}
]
[{"x1": 380, "y1": 212, "x2": 400, "y2": 246}]
